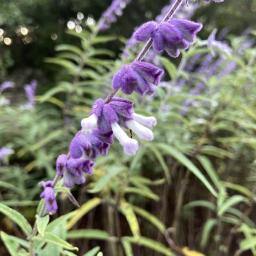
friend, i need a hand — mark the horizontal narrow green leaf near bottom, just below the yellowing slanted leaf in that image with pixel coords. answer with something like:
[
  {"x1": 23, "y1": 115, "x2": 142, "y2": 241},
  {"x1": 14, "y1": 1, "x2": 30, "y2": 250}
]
[{"x1": 67, "y1": 229, "x2": 110, "y2": 240}]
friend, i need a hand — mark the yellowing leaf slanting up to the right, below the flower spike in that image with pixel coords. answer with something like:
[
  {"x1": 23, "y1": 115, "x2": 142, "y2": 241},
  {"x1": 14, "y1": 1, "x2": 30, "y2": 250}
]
[{"x1": 67, "y1": 197, "x2": 101, "y2": 229}]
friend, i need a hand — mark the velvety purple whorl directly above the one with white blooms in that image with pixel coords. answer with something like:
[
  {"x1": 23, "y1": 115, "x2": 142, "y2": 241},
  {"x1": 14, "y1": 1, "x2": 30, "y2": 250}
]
[{"x1": 112, "y1": 61, "x2": 164, "y2": 95}]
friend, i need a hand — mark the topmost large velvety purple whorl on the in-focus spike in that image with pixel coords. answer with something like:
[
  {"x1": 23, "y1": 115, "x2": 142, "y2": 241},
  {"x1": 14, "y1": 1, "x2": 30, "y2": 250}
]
[{"x1": 134, "y1": 19, "x2": 202, "y2": 58}]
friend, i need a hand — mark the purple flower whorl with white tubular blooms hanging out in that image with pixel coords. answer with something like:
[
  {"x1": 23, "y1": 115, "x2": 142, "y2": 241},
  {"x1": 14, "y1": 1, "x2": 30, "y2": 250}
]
[{"x1": 82, "y1": 97, "x2": 156, "y2": 155}]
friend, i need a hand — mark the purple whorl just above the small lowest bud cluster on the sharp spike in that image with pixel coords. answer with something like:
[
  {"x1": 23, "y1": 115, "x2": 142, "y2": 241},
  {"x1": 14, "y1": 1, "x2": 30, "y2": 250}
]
[{"x1": 56, "y1": 154, "x2": 94, "y2": 188}]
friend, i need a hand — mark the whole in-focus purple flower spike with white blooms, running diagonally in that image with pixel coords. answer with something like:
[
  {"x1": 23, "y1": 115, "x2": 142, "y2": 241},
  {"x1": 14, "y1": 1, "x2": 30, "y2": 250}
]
[{"x1": 41, "y1": 4, "x2": 202, "y2": 213}]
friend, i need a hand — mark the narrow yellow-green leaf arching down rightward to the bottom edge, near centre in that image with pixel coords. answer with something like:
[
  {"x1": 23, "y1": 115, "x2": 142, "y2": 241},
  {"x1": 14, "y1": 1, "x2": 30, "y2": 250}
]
[{"x1": 124, "y1": 236, "x2": 175, "y2": 256}]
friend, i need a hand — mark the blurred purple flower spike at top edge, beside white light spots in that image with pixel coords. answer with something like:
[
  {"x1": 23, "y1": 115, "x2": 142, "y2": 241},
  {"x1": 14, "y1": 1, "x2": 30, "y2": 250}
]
[{"x1": 98, "y1": 0, "x2": 131, "y2": 31}]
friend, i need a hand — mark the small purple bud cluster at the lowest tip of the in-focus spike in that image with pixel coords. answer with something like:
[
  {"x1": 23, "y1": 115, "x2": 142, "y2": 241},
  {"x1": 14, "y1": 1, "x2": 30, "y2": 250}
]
[{"x1": 40, "y1": 180, "x2": 58, "y2": 214}]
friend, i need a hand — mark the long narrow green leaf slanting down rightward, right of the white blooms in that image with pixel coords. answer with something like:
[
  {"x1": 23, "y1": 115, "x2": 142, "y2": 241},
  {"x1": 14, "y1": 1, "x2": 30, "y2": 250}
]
[{"x1": 157, "y1": 143, "x2": 217, "y2": 197}]
